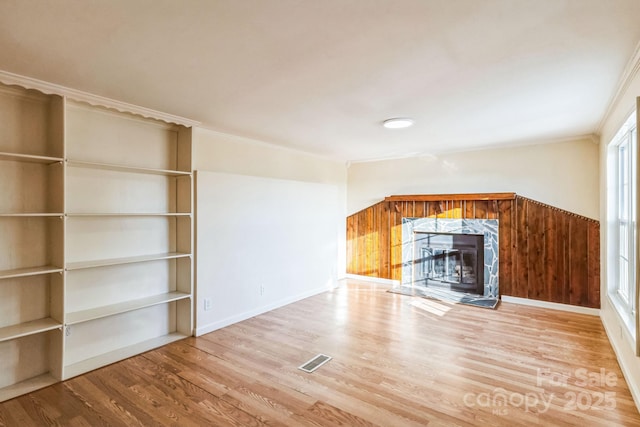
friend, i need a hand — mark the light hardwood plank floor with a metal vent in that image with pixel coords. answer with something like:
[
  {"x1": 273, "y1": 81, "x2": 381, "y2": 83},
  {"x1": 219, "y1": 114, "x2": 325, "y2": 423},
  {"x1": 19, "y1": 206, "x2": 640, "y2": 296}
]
[{"x1": 0, "y1": 281, "x2": 640, "y2": 427}]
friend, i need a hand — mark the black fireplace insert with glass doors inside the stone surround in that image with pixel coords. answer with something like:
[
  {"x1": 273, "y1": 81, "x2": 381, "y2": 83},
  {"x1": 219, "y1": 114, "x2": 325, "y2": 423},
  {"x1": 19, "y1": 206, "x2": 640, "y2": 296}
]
[{"x1": 413, "y1": 231, "x2": 485, "y2": 295}]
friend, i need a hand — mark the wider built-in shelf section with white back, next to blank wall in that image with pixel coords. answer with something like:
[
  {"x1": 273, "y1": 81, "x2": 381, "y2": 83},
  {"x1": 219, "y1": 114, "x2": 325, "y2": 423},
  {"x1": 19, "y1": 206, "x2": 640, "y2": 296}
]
[{"x1": 63, "y1": 102, "x2": 193, "y2": 379}]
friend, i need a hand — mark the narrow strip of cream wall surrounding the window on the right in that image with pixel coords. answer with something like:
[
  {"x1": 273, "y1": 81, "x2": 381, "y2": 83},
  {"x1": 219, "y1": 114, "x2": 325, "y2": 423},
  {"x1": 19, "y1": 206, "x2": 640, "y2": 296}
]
[{"x1": 600, "y1": 59, "x2": 640, "y2": 407}]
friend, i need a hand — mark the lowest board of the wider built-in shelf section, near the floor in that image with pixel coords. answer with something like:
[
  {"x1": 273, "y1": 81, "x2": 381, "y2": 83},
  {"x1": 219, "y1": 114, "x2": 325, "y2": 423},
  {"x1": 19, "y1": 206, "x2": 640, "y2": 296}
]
[{"x1": 63, "y1": 332, "x2": 187, "y2": 380}]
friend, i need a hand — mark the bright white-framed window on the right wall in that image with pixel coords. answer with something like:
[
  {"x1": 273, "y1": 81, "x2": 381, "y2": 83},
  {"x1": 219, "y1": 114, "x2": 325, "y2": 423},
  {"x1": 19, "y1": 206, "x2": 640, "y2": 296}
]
[{"x1": 608, "y1": 112, "x2": 638, "y2": 335}]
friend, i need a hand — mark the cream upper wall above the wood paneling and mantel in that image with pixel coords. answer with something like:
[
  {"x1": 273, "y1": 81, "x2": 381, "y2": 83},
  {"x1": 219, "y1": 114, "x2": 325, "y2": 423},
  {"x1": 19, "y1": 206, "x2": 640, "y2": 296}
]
[{"x1": 347, "y1": 139, "x2": 600, "y2": 219}]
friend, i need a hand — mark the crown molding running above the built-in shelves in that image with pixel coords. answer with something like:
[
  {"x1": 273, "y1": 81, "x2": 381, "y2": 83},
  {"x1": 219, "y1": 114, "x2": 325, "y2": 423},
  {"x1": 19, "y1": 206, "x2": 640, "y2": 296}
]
[{"x1": 0, "y1": 70, "x2": 200, "y2": 127}]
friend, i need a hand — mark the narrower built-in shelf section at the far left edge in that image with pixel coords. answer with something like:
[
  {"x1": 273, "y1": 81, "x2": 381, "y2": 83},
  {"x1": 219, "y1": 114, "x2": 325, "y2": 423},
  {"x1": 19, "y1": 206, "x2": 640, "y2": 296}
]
[{"x1": 0, "y1": 86, "x2": 64, "y2": 401}]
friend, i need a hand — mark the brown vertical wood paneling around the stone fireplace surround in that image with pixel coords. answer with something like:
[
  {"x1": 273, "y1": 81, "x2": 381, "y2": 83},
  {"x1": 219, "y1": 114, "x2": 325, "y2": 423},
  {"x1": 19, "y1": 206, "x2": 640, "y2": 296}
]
[{"x1": 347, "y1": 193, "x2": 600, "y2": 308}]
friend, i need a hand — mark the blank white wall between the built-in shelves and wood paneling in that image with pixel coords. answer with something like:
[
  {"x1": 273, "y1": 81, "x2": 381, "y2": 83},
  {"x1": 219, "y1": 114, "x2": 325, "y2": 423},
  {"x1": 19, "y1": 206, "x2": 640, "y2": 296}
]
[{"x1": 194, "y1": 129, "x2": 346, "y2": 335}]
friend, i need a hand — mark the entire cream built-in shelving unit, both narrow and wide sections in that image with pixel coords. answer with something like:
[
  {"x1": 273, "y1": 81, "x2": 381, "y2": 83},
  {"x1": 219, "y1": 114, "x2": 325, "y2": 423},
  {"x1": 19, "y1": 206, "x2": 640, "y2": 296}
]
[{"x1": 0, "y1": 85, "x2": 193, "y2": 401}]
